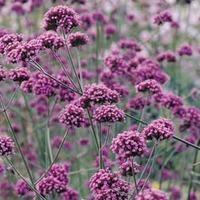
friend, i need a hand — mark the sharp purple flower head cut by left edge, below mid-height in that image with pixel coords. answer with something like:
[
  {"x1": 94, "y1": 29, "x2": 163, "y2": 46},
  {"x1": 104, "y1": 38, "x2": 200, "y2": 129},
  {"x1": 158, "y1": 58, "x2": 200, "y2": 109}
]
[{"x1": 0, "y1": 135, "x2": 15, "y2": 156}]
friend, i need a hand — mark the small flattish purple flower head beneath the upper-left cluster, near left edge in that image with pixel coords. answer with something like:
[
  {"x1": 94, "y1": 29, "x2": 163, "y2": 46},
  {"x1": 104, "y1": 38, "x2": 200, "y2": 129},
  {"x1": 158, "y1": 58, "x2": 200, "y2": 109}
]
[{"x1": 8, "y1": 67, "x2": 30, "y2": 83}]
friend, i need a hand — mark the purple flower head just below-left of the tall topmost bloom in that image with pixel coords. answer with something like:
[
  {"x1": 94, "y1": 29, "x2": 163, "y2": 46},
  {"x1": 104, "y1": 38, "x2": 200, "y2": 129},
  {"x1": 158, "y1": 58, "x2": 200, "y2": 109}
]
[{"x1": 38, "y1": 31, "x2": 64, "y2": 50}]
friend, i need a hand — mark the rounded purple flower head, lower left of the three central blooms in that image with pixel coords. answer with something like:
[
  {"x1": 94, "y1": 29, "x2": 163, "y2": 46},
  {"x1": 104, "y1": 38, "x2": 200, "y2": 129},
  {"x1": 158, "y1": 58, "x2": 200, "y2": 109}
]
[{"x1": 59, "y1": 103, "x2": 85, "y2": 127}]
